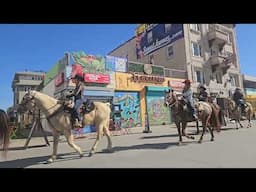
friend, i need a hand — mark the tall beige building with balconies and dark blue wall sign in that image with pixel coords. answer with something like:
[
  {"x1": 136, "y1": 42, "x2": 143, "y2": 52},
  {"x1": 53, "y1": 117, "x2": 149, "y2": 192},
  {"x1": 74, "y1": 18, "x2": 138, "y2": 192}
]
[{"x1": 109, "y1": 24, "x2": 243, "y2": 98}]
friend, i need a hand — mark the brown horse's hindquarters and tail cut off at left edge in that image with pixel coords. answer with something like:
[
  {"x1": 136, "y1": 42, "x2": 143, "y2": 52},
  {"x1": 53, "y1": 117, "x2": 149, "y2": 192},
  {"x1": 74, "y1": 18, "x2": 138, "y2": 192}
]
[{"x1": 0, "y1": 109, "x2": 11, "y2": 157}]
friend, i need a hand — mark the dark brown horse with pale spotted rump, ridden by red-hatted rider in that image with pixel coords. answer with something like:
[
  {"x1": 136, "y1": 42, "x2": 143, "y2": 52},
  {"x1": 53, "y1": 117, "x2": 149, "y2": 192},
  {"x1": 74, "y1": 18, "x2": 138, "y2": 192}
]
[{"x1": 165, "y1": 91, "x2": 214, "y2": 145}]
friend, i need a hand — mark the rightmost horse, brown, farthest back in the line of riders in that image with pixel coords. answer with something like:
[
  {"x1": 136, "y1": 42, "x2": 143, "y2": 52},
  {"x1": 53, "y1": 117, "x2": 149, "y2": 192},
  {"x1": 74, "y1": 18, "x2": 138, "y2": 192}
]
[{"x1": 227, "y1": 98, "x2": 253, "y2": 129}]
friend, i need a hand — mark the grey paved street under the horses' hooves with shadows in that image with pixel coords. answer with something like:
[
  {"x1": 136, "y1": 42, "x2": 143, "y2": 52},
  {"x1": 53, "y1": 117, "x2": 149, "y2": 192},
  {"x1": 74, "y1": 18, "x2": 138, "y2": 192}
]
[{"x1": 0, "y1": 121, "x2": 256, "y2": 168}]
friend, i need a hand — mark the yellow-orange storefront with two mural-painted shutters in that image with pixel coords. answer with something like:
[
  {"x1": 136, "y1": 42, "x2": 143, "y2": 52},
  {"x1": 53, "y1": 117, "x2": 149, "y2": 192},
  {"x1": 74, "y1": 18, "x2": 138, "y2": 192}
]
[{"x1": 113, "y1": 72, "x2": 184, "y2": 127}]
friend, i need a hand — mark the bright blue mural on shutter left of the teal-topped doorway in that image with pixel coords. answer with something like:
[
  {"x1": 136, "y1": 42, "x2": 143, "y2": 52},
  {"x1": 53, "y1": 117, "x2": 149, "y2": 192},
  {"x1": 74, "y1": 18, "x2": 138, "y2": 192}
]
[{"x1": 114, "y1": 92, "x2": 141, "y2": 128}]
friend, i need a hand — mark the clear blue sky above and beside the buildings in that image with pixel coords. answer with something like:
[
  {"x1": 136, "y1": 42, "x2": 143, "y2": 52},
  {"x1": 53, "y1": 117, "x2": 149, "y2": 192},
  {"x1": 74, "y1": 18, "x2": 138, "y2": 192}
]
[{"x1": 0, "y1": 24, "x2": 256, "y2": 109}]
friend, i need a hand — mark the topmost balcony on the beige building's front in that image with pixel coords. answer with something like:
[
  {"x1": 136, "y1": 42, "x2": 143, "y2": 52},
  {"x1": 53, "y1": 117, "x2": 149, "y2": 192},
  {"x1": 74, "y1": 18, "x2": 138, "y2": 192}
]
[{"x1": 208, "y1": 28, "x2": 228, "y2": 47}]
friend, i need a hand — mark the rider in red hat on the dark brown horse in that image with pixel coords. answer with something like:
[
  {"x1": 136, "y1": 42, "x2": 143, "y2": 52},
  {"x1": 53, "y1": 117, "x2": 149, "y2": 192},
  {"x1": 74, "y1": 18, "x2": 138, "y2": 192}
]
[{"x1": 182, "y1": 79, "x2": 197, "y2": 120}]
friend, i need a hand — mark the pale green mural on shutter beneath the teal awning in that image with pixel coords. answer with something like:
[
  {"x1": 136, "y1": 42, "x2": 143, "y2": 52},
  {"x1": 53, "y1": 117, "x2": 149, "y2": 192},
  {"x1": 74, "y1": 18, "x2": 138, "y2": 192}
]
[{"x1": 147, "y1": 95, "x2": 170, "y2": 125}]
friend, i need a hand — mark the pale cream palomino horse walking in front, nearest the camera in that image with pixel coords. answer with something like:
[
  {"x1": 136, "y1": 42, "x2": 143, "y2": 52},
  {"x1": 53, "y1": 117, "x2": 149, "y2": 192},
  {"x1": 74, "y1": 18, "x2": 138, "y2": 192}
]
[{"x1": 20, "y1": 91, "x2": 112, "y2": 163}]
